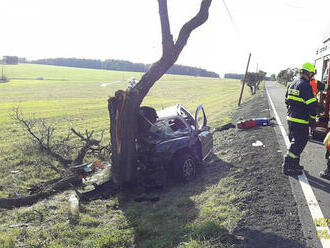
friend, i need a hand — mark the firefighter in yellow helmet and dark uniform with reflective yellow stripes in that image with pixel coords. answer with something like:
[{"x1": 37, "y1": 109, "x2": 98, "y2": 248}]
[{"x1": 283, "y1": 63, "x2": 317, "y2": 175}]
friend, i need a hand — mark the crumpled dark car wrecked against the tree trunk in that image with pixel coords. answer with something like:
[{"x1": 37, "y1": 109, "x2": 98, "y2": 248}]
[{"x1": 137, "y1": 104, "x2": 213, "y2": 181}]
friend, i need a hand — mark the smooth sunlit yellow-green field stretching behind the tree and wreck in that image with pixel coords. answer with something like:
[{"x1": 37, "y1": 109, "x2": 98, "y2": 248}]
[{"x1": 0, "y1": 64, "x2": 250, "y2": 151}]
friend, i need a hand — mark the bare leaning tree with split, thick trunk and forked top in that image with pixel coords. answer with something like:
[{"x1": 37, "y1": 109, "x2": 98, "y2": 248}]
[{"x1": 108, "y1": 0, "x2": 212, "y2": 185}]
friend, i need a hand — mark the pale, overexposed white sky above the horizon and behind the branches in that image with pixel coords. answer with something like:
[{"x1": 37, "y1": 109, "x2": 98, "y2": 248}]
[{"x1": 0, "y1": 0, "x2": 330, "y2": 76}]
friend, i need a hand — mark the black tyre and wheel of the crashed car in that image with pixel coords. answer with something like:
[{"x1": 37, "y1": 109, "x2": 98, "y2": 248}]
[{"x1": 173, "y1": 153, "x2": 197, "y2": 182}]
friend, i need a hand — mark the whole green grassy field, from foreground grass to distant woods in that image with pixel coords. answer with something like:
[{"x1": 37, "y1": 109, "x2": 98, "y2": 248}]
[{"x1": 0, "y1": 64, "x2": 255, "y2": 247}]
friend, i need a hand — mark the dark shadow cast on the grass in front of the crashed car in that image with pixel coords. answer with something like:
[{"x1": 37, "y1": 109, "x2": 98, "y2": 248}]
[{"x1": 119, "y1": 155, "x2": 233, "y2": 248}]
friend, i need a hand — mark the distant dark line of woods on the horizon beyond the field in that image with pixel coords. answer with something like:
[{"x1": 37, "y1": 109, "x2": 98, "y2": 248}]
[{"x1": 30, "y1": 58, "x2": 219, "y2": 78}]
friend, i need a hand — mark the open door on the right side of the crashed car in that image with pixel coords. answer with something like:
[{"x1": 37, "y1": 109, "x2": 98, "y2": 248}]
[{"x1": 195, "y1": 105, "x2": 213, "y2": 160}]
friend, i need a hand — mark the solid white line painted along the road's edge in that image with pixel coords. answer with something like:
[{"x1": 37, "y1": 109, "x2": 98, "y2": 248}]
[{"x1": 266, "y1": 90, "x2": 330, "y2": 248}]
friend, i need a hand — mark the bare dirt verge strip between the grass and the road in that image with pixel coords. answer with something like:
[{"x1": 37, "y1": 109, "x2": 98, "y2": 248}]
[{"x1": 215, "y1": 89, "x2": 306, "y2": 248}]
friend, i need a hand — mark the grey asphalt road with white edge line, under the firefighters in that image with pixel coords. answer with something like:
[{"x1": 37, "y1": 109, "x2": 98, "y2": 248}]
[{"x1": 265, "y1": 82, "x2": 330, "y2": 248}]
